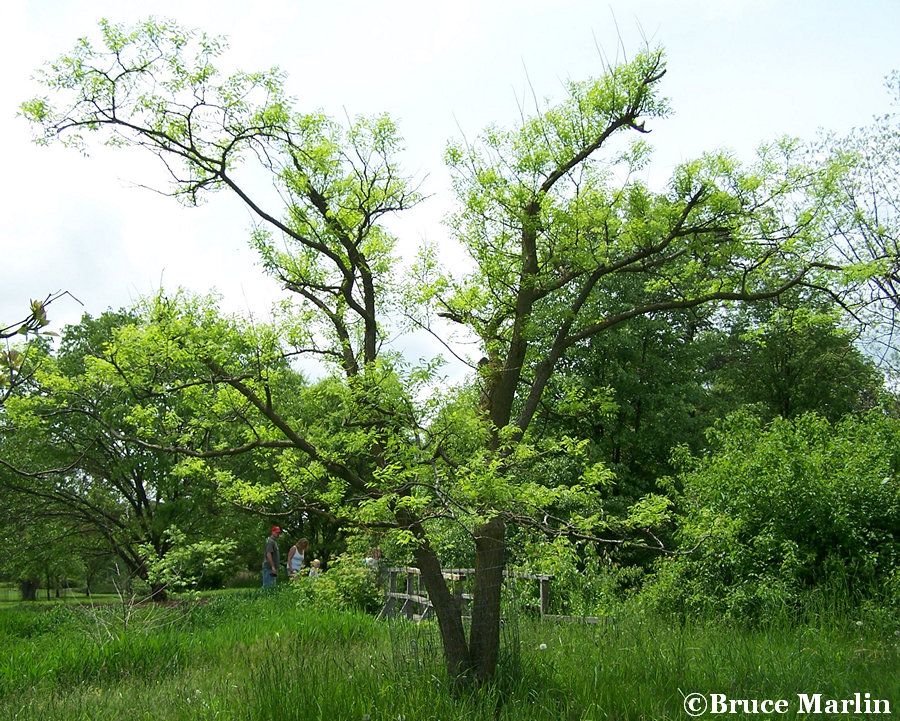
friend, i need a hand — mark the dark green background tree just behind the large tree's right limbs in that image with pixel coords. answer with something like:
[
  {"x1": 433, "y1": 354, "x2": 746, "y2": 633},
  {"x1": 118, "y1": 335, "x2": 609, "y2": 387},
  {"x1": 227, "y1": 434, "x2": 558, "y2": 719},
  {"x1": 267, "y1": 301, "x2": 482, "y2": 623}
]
[{"x1": 535, "y1": 300, "x2": 717, "y2": 500}]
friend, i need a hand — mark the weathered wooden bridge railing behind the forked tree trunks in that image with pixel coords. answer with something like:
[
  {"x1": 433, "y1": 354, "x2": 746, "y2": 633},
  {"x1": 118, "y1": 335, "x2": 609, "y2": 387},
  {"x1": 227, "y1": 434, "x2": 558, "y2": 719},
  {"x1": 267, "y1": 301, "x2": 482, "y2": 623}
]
[{"x1": 378, "y1": 567, "x2": 598, "y2": 623}]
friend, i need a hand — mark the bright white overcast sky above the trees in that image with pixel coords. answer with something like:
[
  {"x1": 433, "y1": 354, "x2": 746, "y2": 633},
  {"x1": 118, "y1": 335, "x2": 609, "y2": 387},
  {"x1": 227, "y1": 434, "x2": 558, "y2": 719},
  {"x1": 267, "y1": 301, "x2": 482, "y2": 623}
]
[{"x1": 0, "y1": 0, "x2": 900, "y2": 372}]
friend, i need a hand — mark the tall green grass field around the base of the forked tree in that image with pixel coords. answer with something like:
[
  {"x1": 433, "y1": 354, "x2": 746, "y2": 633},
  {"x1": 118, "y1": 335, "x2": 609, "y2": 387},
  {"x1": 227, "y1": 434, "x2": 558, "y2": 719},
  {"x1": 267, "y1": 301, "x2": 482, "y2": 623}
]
[{"x1": 0, "y1": 591, "x2": 900, "y2": 721}]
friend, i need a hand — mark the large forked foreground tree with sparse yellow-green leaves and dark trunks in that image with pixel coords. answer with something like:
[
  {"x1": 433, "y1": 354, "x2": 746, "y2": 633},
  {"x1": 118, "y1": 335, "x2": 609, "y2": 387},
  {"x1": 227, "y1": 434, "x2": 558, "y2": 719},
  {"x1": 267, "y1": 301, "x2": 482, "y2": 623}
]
[{"x1": 23, "y1": 15, "x2": 852, "y2": 680}]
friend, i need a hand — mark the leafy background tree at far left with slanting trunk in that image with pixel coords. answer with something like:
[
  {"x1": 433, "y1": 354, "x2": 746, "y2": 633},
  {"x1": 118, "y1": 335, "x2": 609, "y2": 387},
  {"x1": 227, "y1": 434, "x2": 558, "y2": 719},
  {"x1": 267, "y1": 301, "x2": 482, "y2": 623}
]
[{"x1": 0, "y1": 302, "x2": 260, "y2": 596}]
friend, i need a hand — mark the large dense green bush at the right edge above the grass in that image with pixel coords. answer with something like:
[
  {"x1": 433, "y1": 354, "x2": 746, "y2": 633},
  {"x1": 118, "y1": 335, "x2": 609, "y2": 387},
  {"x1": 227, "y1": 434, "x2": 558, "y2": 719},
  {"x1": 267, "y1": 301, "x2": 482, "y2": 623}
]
[{"x1": 647, "y1": 412, "x2": 900, "y2": 616}]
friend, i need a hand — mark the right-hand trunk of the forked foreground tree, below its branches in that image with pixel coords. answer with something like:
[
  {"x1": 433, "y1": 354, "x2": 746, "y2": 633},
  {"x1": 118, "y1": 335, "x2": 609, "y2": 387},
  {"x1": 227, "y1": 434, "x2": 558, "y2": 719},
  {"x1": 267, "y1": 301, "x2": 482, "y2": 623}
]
[{"x1": 469, "y1": 517, "x2": 506, "y2": 684}]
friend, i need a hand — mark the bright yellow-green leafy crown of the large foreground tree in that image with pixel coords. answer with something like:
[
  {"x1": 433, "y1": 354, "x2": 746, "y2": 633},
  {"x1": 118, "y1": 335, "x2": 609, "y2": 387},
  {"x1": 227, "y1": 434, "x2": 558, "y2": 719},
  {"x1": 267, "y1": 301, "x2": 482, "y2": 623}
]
[{"x1": 17, "y1": 19, "x2": 880, "y2": 678}]
